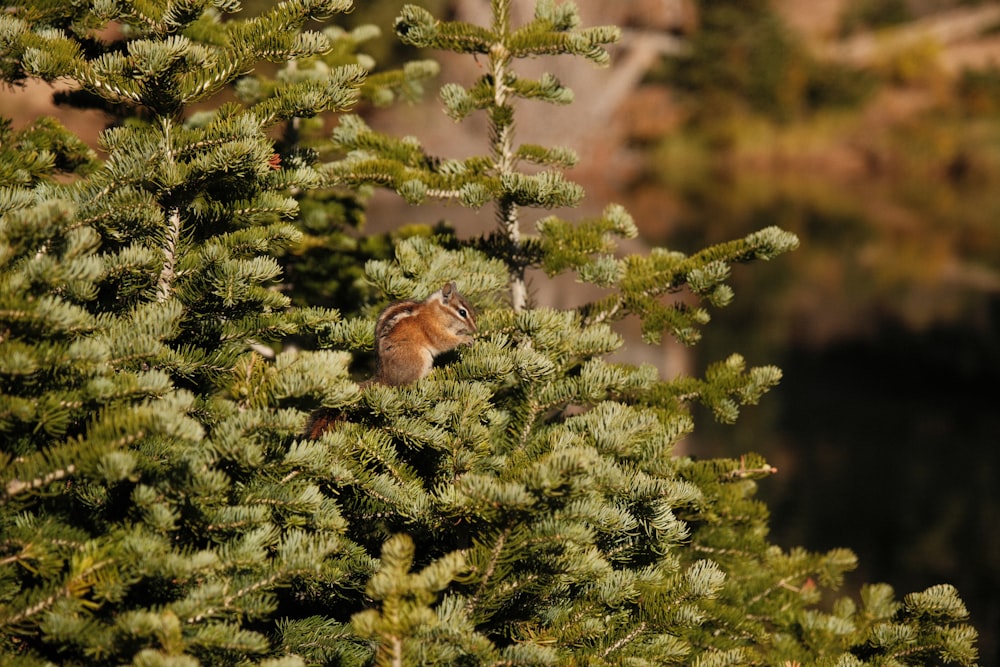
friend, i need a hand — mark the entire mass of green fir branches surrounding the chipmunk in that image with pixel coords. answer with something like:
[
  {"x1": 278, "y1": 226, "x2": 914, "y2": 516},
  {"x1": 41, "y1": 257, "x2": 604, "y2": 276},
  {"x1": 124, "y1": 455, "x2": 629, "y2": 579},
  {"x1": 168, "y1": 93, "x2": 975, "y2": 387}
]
[{"x1": 0, "y1": 0, "x2": 976, "y2": 666}]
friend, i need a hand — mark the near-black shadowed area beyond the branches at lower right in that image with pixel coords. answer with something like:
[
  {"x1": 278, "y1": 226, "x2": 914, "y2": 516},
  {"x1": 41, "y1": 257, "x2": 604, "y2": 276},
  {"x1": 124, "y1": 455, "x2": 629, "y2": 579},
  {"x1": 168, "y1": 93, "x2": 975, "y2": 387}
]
[{"x1": 735, "y1": 310, "x2": 1000, "y2": 665}]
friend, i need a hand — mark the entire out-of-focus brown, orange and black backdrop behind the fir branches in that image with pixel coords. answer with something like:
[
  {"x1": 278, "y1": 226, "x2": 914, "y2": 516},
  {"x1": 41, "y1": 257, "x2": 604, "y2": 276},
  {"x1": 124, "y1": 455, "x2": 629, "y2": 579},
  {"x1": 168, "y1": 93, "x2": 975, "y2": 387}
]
[{"x1": 0, "y1": 0, "x2": 1000, "y2": 665}]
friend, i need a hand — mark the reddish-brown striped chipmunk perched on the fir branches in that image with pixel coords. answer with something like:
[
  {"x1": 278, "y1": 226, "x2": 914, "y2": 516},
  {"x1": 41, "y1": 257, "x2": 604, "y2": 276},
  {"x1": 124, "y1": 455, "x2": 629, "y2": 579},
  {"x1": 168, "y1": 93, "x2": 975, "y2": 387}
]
[{"x1": 306, "y1": 282, "x2": 476, "y2": 440}]
